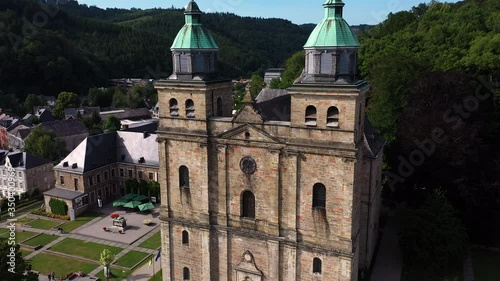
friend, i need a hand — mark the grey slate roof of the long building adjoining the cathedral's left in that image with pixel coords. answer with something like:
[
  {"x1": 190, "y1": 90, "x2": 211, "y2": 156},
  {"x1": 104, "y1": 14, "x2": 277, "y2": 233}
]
[{"x1": 55, "y1": 131, "x2": 159, "y2": 173}]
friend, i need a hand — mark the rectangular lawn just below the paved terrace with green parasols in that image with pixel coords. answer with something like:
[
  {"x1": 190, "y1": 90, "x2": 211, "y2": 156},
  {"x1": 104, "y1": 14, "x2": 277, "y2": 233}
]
[{"x1": 51, "y1": 238, "x2": 123, "y2": 260}]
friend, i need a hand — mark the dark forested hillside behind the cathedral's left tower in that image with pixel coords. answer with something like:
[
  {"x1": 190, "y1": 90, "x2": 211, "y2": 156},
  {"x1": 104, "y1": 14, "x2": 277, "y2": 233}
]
[{"x1": 0, "y1": 0, "x2": 313, "y2": 101}]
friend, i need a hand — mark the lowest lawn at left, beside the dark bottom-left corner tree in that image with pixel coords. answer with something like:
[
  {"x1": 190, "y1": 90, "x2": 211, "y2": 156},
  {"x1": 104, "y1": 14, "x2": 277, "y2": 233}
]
[{"x1": 30, "y1": 250, "x2": 99, "y2": 278}]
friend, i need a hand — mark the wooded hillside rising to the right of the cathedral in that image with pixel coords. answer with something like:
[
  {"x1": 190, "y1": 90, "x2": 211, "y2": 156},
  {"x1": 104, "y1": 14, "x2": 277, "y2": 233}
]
[{"x1": 360, "y1": 0, "x2": 500, "y2": 274}]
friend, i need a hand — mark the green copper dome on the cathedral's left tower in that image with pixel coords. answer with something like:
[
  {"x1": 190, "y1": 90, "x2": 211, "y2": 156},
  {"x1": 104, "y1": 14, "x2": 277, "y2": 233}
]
[{"x1": 171, "y1": 1, "x2": 219, "y2": 49}]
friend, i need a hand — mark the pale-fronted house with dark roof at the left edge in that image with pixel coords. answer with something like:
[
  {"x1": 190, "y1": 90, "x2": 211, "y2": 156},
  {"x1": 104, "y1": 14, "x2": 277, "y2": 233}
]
[{"x1": 0, "y1": 151, "x2": 54, "y2": 198}]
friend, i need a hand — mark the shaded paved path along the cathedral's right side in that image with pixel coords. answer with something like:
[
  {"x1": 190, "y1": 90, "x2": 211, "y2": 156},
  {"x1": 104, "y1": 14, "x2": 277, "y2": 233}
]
[{"x1": 370, "y1": 210, "x2": 403, "y2": 281}]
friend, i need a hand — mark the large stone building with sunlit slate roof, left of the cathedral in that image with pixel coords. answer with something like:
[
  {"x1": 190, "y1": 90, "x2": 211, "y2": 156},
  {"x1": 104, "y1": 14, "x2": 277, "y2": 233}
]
[{"x1": 44, "y1": 131, "x2": 159, "y2": 216}]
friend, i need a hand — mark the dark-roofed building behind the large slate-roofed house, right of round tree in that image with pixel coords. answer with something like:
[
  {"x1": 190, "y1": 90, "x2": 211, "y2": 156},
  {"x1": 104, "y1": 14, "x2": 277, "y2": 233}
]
[{"x1": 39, "y1": 119, "x2": 89, "y2": 151}]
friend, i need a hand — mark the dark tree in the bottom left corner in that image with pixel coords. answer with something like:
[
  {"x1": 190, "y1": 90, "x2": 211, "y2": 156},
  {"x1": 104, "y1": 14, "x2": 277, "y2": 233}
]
[{"x1": 0, "y1": 240, "x2": 38, "y2": 281}]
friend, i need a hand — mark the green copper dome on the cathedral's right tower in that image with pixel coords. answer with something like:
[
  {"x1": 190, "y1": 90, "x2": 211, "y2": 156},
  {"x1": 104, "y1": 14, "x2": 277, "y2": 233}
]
[{"x1": 304, "y1": 0, "x2": 360, "y2": 48}]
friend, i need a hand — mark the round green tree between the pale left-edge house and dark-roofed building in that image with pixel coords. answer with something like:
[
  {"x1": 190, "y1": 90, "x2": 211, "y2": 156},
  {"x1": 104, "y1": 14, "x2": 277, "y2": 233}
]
[{"x1": 24, "y1": 127, "x2": 66, "y2": 161}]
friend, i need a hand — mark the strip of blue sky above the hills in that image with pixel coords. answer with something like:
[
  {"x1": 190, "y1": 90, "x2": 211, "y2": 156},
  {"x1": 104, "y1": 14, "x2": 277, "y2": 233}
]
[{"x1": 79, "y1": 0, "x2": 457, "y2": 25}]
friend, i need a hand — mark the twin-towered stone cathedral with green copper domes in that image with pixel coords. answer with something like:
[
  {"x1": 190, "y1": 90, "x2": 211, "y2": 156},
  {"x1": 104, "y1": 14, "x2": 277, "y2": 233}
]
[{"x1": 155, "y1": 0, "x2": 385, "y2": 281}]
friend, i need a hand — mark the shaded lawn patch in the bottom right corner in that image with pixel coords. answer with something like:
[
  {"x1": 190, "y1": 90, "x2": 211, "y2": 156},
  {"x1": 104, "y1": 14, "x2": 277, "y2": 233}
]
[{"x1": 471, "y1": 249, "x2": 500, "y2": 281}]
